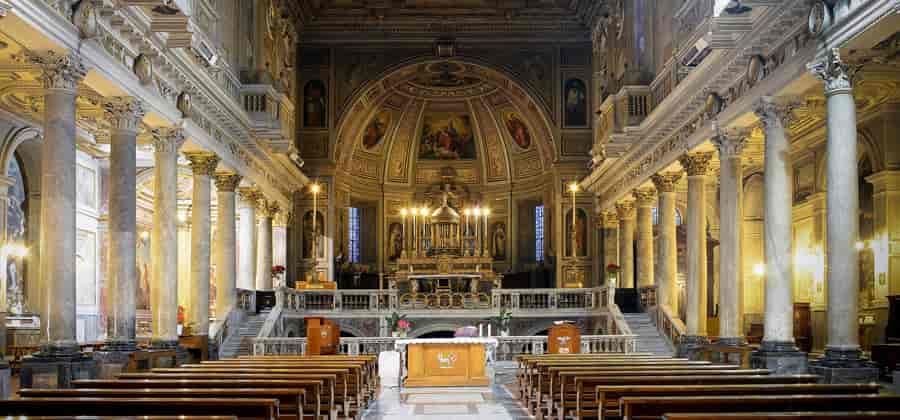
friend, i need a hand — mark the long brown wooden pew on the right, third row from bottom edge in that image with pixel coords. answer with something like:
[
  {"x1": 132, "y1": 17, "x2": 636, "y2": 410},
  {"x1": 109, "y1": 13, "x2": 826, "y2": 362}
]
[{"x1": 596, "y1": 384, "x2": 880, "y2": 420}]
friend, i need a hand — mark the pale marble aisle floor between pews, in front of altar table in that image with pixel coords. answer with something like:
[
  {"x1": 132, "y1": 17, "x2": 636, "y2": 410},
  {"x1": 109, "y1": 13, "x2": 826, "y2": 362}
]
[{"x1": 362, "y1": 367, "x2": 531, "y2": 420}]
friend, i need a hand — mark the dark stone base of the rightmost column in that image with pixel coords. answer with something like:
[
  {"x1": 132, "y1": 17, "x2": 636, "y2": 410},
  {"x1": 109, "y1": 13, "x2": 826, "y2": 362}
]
[{"x1": 809, "y1": 347, "x2": 878, "y2": 384}]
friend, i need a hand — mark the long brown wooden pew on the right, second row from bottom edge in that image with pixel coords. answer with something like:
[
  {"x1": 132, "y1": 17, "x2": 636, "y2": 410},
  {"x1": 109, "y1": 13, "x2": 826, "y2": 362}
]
[{"x1": 621, "y1": 394, "x2": 900, "y2": 420}]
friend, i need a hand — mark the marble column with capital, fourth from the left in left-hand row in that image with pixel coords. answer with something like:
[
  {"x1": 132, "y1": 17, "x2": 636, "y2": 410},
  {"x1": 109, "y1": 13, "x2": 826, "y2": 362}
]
[{"x1": 185, "y1": 152, "x2": 219, "y2": 335}]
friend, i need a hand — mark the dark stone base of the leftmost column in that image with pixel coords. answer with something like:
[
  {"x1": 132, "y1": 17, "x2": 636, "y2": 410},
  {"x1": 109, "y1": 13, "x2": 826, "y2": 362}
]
[{"x1": 19, "y1": 344, "x2": 99, "y2": 388}]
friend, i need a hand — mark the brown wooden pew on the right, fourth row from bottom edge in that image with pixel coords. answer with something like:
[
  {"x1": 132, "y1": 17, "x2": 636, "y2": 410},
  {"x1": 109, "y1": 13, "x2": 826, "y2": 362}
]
[{"x1": 574, "y1": 375, "x2": 820, "y2": 417}]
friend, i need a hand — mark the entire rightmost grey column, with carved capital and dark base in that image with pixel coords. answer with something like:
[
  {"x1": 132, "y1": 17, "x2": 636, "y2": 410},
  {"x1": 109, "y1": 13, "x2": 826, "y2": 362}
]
[{"x1": 809, "y1": 49, "x2": 877, "y2": 382}]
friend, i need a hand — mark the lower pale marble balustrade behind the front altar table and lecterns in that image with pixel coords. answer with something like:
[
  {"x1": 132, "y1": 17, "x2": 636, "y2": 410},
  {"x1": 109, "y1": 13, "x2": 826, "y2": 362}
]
[{"x1": 253, "y1": 334, "x2": 637, "y2": 360}]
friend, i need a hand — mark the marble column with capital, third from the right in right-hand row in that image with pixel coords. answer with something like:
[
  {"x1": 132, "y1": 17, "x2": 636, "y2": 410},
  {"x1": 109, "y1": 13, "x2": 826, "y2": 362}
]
[{"x1": 713, "y1": 129, "x2": 750, "y2": 346}]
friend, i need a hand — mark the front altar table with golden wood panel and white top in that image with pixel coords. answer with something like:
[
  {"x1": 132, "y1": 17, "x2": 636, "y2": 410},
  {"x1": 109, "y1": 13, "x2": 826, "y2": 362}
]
[{"x1": 394, "y1": 337, "x2": 497, "y2": 387}]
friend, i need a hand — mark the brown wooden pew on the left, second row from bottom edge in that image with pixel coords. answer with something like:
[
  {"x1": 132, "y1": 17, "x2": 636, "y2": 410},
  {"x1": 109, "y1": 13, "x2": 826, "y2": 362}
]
[{"x1": 0, "y1": 398, "x2": 278, "y2": 420}]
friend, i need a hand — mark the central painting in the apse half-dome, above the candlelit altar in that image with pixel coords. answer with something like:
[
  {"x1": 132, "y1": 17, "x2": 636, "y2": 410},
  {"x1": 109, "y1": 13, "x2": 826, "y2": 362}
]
[{"x1": 419, "y1": 112, "x2": 475, "y2": 160}]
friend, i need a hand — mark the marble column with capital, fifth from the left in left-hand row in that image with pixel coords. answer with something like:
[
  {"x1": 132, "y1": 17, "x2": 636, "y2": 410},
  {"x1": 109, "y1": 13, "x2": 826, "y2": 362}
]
[{"x1": 215, "y1": 173, "x2": 241, "y2": 321}]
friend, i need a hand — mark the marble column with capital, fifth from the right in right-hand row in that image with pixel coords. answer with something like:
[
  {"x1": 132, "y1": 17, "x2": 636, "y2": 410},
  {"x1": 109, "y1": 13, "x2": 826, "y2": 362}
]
[{"x1": 652, "y1": 172, "x2": 681, "y2": 314}]
